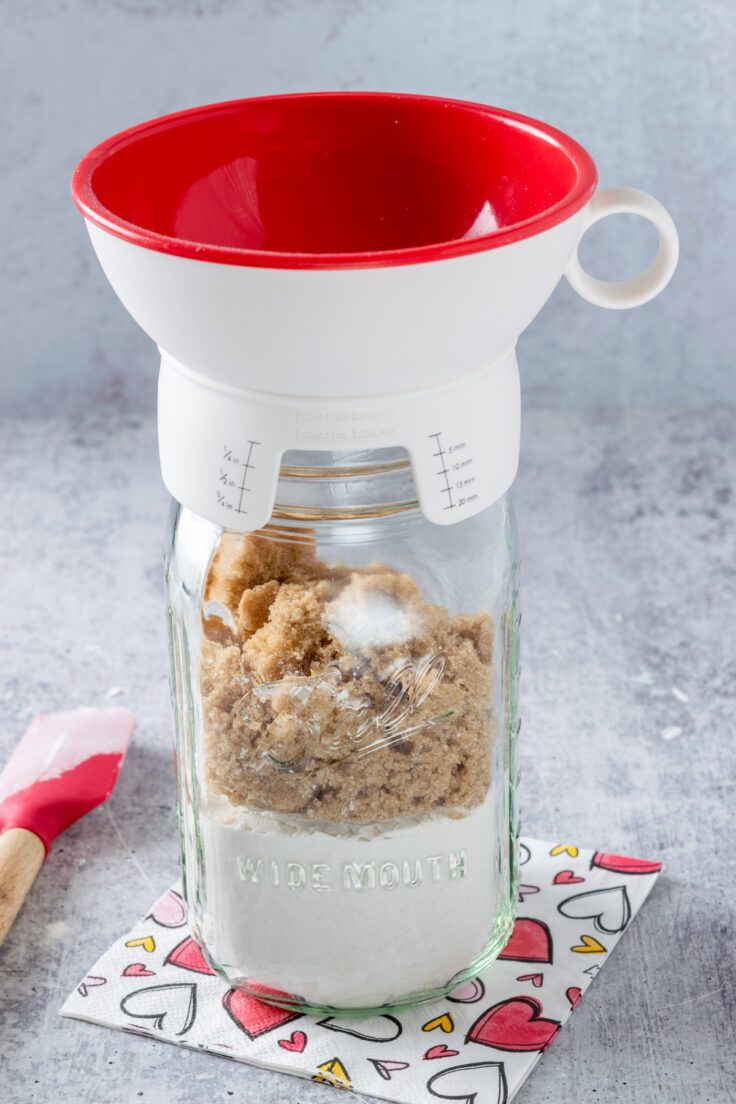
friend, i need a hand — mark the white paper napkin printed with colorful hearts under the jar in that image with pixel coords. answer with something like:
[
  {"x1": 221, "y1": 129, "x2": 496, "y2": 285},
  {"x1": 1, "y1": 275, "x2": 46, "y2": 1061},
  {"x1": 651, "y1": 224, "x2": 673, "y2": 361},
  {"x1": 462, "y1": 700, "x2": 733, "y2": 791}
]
[{"x1": 62, "y1": 839, "x2": 660, "y2": 1104}]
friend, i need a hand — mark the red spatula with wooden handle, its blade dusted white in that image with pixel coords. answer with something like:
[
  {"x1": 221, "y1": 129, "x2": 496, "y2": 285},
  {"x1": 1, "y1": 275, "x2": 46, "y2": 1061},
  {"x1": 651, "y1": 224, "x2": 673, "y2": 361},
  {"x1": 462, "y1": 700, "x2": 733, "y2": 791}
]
[{"x1": 0, "y1": 709, "x2": 136, "y2": 943}]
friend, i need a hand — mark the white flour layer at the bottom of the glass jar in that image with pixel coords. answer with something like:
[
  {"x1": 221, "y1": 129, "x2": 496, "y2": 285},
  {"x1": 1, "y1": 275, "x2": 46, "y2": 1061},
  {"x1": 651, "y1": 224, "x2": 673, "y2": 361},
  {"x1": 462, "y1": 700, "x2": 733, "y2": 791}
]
[{"x1": 200, "y1": 792, "x2": 499, "y2": 1008}]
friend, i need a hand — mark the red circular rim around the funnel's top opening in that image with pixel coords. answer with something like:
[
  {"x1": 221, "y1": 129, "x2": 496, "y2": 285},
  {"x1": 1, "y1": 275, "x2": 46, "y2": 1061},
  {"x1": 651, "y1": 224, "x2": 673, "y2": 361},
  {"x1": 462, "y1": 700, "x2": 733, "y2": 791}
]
[{"x1": 72, "y1": 92, "x2": 597, "y2": 269}]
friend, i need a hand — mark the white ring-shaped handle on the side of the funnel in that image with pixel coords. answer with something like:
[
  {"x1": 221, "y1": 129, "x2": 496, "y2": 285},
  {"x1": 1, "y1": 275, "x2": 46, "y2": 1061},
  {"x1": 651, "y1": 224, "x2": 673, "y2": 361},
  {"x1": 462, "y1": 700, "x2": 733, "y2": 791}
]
[{"x1": 565, "y1": 188, "x2": 679, "y2": 310}]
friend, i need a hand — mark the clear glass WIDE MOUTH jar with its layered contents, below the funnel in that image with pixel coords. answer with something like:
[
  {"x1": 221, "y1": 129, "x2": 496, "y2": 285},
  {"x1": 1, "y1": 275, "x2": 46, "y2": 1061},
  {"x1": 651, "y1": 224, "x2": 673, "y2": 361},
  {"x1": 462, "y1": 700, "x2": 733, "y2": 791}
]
[{"x1": 166, "y1": 449, "x2": 519, "y2": 1015}]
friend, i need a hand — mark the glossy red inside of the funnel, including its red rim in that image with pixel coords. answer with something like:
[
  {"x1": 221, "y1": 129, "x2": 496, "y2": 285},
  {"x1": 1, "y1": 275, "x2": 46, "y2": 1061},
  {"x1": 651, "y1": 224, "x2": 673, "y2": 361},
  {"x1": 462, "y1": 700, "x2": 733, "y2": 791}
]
[{"x1": 72, "y1": 93, "x2": 596, "y2": 267}]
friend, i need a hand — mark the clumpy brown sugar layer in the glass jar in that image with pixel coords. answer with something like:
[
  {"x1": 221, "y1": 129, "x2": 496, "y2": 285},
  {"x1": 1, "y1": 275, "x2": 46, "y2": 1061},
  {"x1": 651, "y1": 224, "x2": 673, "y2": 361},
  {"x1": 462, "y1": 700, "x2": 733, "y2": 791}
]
[{"x1": 201, "y1": 534, "x2": 495, "y2": 824}]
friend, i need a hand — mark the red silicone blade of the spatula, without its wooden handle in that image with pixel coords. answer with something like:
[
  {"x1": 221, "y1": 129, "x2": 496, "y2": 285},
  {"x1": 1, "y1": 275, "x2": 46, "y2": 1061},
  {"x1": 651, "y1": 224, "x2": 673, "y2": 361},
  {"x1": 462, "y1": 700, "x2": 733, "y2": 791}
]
[{"x1": 0, "y1": 709, "x2": 136, "y2": 850}]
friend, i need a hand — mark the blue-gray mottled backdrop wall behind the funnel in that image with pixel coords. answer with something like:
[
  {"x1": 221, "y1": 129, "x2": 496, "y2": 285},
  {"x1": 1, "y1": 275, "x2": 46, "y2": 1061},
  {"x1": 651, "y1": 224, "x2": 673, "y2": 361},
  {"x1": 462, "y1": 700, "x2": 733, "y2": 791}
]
[{"x1": 0, "y1": 0, "x2": 736, "y2": 416}]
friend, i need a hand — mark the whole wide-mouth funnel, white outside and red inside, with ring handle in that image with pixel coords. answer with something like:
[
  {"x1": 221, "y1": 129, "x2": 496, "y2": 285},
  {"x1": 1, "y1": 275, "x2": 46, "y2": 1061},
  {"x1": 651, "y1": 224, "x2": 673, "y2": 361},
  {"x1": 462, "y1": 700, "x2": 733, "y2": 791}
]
[{"x1": 72, "y1": 93, "x2": 678, "y2": 531}]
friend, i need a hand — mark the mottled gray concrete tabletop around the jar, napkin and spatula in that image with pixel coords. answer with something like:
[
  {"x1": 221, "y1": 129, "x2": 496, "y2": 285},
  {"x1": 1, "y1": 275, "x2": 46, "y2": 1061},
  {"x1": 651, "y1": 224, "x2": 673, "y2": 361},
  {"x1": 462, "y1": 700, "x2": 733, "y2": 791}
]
[{"x1": 0, "y1": 407, "x2": 736, "y2": 1104}]
